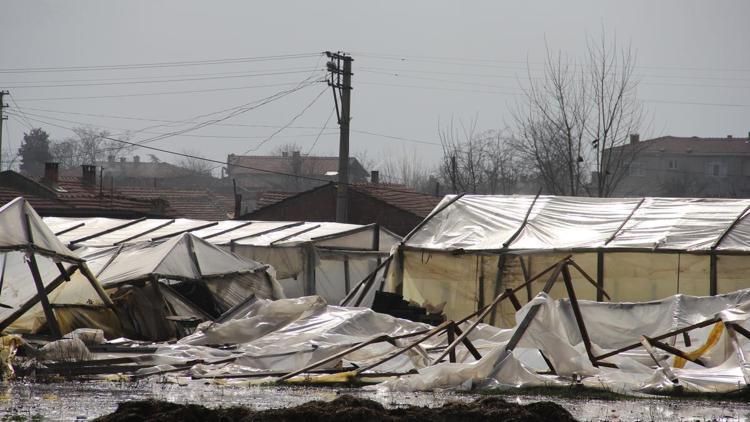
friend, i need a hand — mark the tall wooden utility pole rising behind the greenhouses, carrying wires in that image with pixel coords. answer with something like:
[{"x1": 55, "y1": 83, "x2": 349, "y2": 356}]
[{"x1": 326, "y1": 52, "x2": 354, "y2": 223}]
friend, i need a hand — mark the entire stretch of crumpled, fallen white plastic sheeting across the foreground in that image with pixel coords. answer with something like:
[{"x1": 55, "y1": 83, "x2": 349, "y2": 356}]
[{"x1": 89, "y1": 290, "x2": 750, "y2": 393}]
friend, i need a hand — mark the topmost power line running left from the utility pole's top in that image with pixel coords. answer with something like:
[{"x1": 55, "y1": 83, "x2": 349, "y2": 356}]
[{"x1": 0, "y1": 53, "x2": 322, "y2": 73}]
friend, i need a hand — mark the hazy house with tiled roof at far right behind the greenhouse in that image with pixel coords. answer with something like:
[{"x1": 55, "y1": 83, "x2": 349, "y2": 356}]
[{"x1": 613, "y1": 135, "x2": 750, "y2": 198}]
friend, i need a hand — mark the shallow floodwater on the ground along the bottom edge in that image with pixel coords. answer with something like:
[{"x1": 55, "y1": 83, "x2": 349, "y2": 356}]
[{"x1": 0, "y1": 380, "x2": 750, "y2": 422}]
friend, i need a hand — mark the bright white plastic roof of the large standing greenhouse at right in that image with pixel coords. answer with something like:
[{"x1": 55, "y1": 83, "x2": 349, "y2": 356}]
[{"x1": 406, "y1": 195, "x2": 750, "y2": 252}]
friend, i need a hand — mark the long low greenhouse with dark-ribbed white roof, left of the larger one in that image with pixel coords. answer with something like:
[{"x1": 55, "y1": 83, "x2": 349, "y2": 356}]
[{"x1": 45, "y1": 217, "x2": 400, "y2": 303}]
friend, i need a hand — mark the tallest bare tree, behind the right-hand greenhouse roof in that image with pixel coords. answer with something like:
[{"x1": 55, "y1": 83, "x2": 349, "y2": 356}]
[{"x1": 513, "y1": 34, "x2": 644, "y2": 197}]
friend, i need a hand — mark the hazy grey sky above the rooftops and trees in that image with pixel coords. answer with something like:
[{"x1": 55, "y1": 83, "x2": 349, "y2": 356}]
[{"x1": 0, "y1": 0, "x2": 750, "y2": 176}]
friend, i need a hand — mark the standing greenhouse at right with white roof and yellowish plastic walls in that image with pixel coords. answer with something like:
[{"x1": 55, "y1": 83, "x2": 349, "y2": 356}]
[{"x1": 389, "y1": 195, "x2": 750, "y2": 326}]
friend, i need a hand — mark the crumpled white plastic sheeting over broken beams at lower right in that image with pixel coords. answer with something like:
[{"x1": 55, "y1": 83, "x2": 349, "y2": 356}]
[{"x1": 377, "y1": 290, "x2": 750, "y2": 393}]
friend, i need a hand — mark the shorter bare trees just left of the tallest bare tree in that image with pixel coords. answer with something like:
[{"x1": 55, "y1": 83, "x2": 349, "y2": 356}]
[{"x1": 440, "y1": 119, "x2": 521, "y2": 194}]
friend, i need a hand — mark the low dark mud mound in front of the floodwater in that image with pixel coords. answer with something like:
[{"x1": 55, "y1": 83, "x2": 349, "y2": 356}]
[{"x1": 96, "y1": 395, "x2": 575, "y2": 422}]
